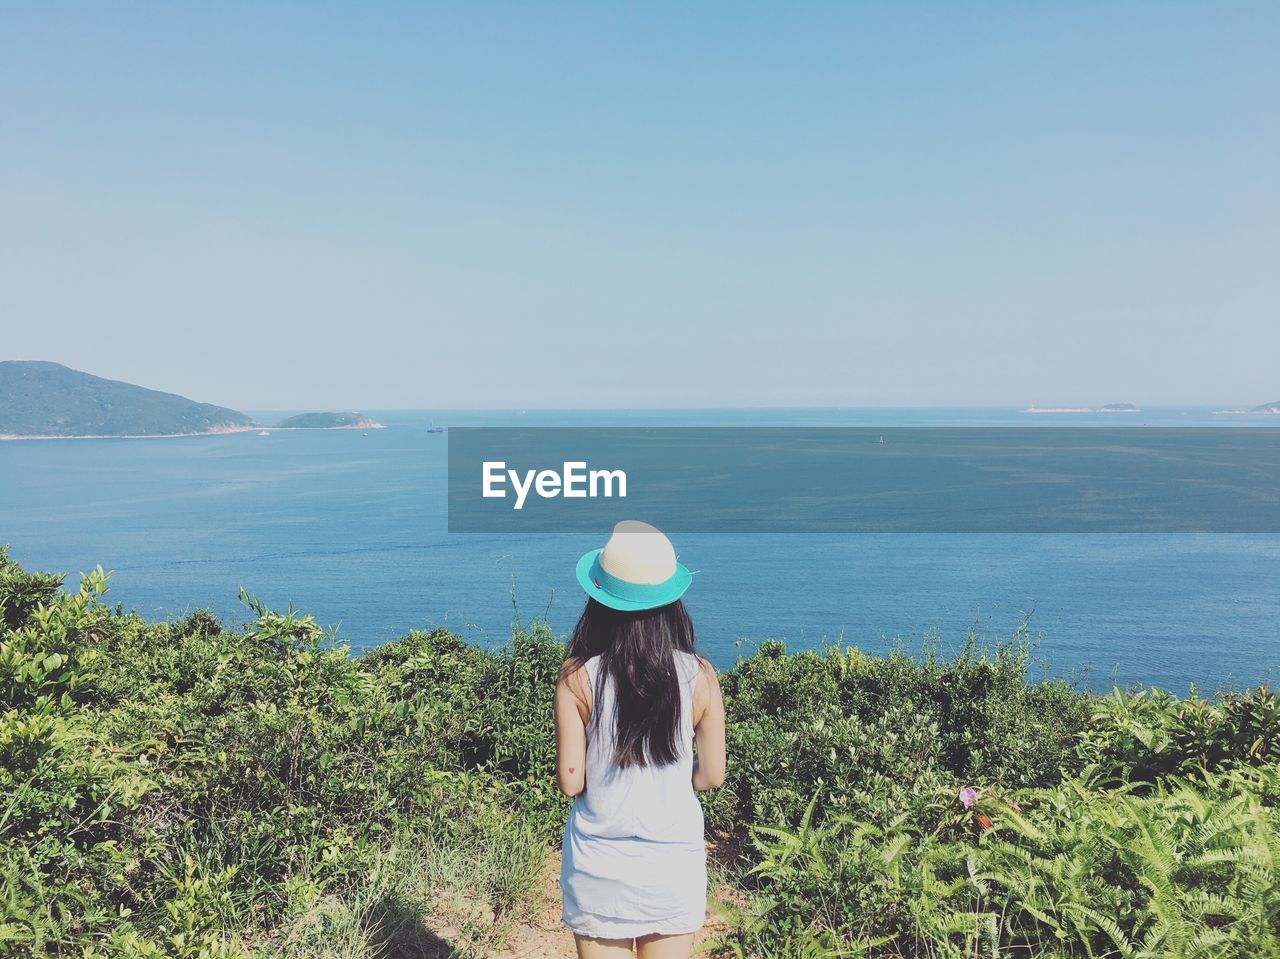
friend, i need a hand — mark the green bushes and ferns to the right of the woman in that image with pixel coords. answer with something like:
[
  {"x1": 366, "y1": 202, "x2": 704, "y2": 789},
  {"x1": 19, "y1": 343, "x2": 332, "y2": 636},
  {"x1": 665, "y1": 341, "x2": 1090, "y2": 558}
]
[{"x1": 717, "y1": 636, "x2": 1280, "y2": 956}]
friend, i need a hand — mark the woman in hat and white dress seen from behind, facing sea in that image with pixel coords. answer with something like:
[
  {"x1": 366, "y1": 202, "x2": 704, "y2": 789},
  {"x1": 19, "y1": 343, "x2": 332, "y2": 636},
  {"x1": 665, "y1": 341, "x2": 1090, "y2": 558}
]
[{"x1": 556, "y1": 521, "x2": 724, "y2": 959}]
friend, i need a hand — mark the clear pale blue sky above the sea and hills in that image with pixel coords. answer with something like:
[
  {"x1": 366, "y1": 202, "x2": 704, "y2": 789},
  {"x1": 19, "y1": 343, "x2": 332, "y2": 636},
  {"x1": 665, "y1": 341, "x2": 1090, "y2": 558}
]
[{"x1": 0, "y1": 0, "x2": 1280, "y2": 408}]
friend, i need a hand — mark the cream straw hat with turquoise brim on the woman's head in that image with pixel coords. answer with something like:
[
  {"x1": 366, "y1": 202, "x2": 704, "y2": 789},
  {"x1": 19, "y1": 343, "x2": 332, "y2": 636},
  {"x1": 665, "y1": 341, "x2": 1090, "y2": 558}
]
[{"x1": 577, "y1": 520, "x2": 694, "y2": 609}]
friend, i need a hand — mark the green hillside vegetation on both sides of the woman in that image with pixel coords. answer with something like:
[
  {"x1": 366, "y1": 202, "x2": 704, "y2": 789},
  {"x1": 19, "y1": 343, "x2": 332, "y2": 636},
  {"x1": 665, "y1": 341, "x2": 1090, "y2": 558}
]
[{"x1": 0, "y1": 553, "x2": 1280, "y2": 959}]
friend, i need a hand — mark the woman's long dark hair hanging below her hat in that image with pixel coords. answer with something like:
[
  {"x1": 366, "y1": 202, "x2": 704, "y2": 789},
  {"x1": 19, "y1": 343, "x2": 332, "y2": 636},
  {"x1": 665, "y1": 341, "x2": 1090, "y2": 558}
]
[{"x1": 568, "y1": 599, "x2": 694, "y2": 768}]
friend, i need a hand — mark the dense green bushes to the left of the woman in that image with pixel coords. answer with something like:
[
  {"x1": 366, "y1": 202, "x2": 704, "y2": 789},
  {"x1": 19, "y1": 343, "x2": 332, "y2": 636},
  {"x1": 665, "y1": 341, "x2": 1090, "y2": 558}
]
[{"x1": 0, "y1": 553, "x2": 550, "y2": 959}]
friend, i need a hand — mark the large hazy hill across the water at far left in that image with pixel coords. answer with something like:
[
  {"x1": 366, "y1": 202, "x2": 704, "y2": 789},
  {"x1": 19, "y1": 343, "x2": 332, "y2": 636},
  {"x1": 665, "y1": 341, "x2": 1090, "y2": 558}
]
[{"x1": 0, "y1": 360, "x2": 253, "y2": 437}]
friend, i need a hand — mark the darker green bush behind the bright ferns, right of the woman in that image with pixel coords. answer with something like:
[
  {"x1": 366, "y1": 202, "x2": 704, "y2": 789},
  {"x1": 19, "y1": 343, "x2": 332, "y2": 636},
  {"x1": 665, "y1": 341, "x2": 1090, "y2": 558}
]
[{"x1": 714, "y1": 635, "x2": 1092, "y2": 828}]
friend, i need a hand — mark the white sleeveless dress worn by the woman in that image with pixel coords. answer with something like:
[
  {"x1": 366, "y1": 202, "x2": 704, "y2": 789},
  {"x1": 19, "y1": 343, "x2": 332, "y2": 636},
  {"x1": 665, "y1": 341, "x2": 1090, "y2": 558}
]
[{"x1": 561, "y1": 652, "x2": 707, "y2": 939}]
